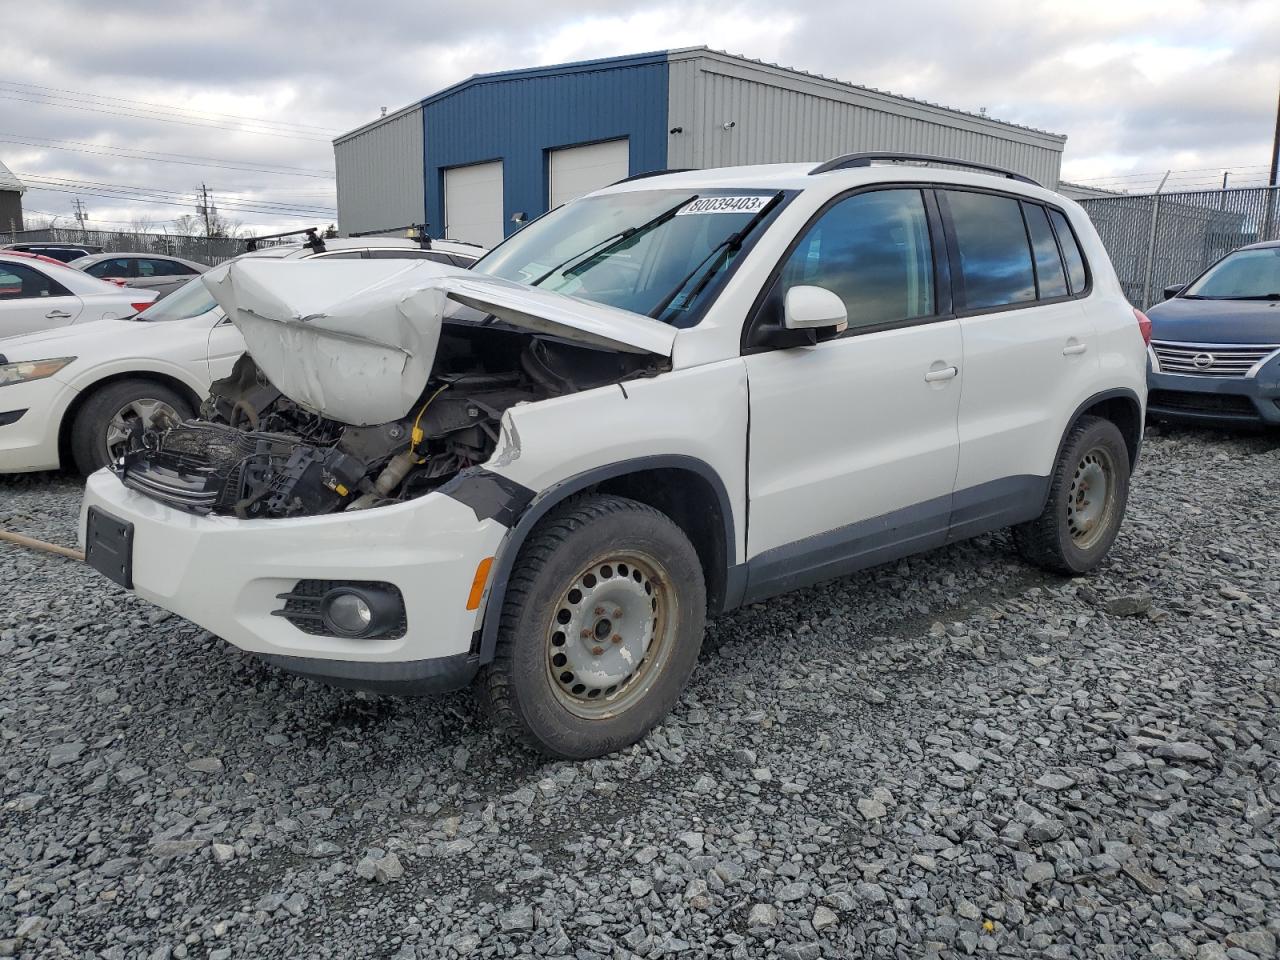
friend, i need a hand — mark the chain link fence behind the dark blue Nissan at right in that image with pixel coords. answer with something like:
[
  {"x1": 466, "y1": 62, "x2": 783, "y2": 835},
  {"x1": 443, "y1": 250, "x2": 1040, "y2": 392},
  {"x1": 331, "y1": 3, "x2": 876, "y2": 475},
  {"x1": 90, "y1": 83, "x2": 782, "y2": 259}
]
[{"x1": 1078, "y1": 187, "x2": 1280, "y2": 310}]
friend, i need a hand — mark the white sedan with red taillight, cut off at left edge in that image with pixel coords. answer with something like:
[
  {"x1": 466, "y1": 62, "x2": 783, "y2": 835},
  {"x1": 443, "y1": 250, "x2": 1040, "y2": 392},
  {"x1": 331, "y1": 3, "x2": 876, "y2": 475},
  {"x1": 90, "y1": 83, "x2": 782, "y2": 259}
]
[{"x1": 0, "y1": 252, "x2": 157, "y2": 338}]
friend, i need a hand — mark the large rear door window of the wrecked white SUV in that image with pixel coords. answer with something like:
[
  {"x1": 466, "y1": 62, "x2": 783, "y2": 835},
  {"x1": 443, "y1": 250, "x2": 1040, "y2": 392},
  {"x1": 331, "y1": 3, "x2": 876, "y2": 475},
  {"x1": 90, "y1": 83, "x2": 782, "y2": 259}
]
[{"x1": 940, "y1": 191, "x2": 1036, "y2": 310}]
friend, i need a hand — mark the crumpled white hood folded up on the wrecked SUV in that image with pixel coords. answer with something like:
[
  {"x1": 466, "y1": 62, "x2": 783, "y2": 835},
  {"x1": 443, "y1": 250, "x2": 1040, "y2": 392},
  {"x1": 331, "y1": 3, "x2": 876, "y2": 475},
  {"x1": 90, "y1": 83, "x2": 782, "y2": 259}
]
[{"x1": 201, "y1": 259, "x2": 676, "y2": 426}]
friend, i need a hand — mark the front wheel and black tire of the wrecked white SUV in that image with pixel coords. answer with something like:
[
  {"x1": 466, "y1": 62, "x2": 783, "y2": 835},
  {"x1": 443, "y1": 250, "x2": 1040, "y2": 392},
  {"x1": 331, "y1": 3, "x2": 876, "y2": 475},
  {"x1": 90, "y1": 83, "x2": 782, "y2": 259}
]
[{"x1": 480, "y1": 495, "x2": 707, "y2": 759}]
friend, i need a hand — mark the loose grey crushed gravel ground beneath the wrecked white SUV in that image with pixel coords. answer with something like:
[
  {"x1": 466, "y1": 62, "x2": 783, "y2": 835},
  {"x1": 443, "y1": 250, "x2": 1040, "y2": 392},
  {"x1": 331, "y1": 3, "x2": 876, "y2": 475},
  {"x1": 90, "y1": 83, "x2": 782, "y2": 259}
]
[{"x1": 0, "y1": 431, "x2": 1280, "y2": 960}]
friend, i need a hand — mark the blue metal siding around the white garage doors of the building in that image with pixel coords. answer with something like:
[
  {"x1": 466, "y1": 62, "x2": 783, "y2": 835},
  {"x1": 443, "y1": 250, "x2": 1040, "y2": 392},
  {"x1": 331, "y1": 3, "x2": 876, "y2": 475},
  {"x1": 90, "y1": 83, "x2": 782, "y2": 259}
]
[{"x1": 422, "y1": 54, "x2": 668, "y2": 236}]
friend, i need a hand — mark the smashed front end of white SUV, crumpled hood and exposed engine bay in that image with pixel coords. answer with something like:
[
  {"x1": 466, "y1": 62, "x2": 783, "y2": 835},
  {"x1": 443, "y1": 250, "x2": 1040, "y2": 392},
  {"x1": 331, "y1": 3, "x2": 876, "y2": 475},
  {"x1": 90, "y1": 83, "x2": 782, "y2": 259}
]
[{"x1": 113, "y1": 261, "x2": 669, "y2": 518}]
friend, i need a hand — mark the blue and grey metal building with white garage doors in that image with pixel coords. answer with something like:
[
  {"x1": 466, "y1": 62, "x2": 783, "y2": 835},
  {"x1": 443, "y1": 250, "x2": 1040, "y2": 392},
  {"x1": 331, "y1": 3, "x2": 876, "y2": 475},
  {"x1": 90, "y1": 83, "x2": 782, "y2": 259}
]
[{"x1": 334, "y1": 47, "x2": 1066, "y2": 246}]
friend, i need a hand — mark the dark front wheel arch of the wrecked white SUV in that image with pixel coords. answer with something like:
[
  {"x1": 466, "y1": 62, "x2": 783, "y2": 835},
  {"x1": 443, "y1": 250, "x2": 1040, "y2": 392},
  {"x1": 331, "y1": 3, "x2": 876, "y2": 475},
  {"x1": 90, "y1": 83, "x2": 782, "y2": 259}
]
[{"x1": 476, "y1": 454, "x2": 745, "y2": 663}]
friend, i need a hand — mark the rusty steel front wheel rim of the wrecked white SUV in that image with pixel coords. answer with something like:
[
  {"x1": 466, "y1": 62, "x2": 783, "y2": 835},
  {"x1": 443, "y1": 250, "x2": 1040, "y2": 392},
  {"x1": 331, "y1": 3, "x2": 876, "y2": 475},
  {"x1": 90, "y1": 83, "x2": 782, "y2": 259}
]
[{"x1": 545, "y1": 553, "x2": 678, "y2": 719}]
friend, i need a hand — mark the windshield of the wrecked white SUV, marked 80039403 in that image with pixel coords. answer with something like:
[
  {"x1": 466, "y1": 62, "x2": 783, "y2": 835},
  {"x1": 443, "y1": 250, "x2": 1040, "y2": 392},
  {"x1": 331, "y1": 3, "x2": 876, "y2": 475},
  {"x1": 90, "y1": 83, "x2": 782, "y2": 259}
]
[{"x1": 474, "y1": 189, "x2": 780, "y2": 326}]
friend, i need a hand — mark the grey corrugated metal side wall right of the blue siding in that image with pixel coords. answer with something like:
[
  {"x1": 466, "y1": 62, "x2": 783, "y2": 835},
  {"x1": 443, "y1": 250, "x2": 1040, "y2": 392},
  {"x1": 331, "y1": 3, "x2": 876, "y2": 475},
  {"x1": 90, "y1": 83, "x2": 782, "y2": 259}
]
[{"x1": 667, "y1": 54, "x2": 1066, "y2": 188}]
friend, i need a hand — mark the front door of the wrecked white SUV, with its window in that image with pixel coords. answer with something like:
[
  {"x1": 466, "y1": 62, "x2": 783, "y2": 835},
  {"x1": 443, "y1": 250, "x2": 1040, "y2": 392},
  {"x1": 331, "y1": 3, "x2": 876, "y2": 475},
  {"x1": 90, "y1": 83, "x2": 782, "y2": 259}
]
[{"x1": 745, "y1": 188, "x2": 963, "y2": 600}]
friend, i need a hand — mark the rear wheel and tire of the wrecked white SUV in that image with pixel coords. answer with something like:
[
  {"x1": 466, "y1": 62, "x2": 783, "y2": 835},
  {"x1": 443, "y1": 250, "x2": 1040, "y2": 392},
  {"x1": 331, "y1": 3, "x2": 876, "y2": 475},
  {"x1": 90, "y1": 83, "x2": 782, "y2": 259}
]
[{"x1": 1014, "y1": 416, "x2": 1129, "y2": 576}]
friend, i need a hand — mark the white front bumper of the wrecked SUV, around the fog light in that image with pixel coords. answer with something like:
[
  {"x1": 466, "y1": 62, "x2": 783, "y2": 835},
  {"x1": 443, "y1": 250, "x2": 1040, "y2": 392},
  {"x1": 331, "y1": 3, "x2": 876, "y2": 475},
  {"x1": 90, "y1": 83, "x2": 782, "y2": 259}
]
[{"x1": 81, "y1": 470, "x2": 507, "y2": 692}]
